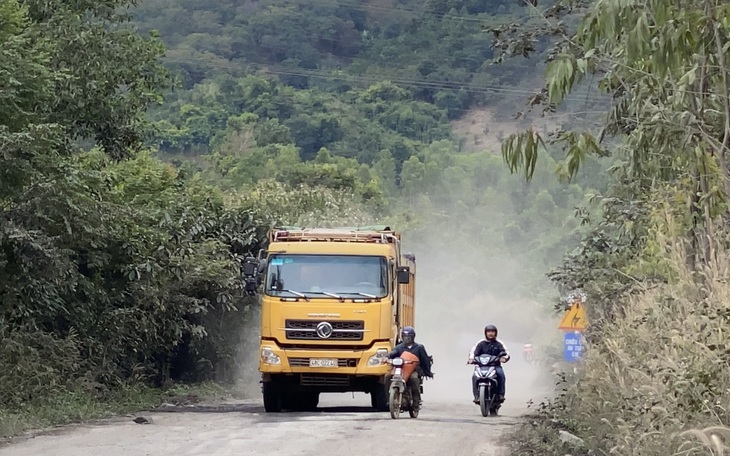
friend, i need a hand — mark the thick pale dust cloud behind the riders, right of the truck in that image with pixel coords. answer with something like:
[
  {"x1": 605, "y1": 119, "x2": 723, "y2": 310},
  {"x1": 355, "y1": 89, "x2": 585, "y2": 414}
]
[{"x1": 403, "y1": 212, "x2": 559, "y2": 414}]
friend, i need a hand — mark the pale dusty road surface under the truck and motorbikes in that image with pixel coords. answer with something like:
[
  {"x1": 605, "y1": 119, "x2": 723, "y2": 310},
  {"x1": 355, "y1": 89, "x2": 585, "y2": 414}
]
[{"x1": 0, "y1": 364, "x2": 544, "y2": 456}]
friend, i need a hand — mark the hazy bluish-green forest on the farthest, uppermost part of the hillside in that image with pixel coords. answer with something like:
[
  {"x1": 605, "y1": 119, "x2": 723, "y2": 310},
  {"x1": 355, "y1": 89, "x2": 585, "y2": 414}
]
[{"x1": 135, "y1": 0, "x2": 544, "y2": 111}]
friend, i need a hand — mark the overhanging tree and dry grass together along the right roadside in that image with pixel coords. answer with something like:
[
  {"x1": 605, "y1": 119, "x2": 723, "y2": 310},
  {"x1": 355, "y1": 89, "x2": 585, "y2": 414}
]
[{"x1": 494, "y1": 0, "x2": 730, "y2": 456}]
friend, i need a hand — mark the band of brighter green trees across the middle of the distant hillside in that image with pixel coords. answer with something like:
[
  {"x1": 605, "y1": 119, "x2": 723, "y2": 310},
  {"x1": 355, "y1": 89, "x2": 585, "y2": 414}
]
[{"x1": 151, "y1": 76, "x2": 450, "y2": 167}]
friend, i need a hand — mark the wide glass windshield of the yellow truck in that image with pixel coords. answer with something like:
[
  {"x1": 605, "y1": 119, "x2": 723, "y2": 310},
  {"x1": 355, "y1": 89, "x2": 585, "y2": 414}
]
[{"x1": 266, "y1": 255, "x2": 388, "y2": 298}]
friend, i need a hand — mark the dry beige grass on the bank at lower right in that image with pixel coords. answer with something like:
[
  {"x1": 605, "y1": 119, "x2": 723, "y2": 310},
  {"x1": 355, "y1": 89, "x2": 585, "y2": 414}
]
[{"x1": 514, "y1": 213, "x2": 730, "y2": 456}]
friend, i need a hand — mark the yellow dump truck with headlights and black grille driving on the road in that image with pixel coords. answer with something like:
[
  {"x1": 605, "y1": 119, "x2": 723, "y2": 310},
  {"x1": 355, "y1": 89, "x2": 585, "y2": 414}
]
[{"x1": 244, "y1": 226, "x2": 416, "y2": 412}]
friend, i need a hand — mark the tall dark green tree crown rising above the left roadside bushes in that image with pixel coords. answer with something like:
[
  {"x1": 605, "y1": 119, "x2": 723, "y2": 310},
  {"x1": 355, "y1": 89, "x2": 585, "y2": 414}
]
[{"x1": 23, "y1": 0, "x2": 168, "y2": 158}]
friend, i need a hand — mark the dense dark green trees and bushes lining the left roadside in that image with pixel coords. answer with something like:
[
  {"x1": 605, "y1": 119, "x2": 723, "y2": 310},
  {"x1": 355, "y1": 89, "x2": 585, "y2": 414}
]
[{"x1": 0, "y1": 1, "x2": 376, "y2": 418}]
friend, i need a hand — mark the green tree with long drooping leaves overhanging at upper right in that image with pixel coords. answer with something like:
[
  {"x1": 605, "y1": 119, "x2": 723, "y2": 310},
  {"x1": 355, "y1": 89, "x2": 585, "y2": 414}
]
[{"x1": 503, "y1": 0, "x2": 730, "y2": 270}]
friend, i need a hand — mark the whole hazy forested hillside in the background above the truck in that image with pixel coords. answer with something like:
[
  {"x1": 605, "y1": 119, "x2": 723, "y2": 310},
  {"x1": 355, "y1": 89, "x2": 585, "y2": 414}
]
[{"x1": 129, "y1": 0, "x2": 596, "y2": 162}]
